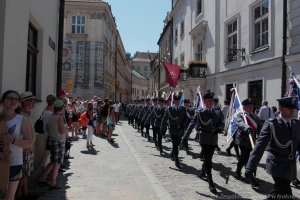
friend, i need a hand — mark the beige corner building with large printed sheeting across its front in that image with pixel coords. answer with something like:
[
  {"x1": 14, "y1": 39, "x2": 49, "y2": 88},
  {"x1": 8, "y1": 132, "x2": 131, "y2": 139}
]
[{"x1": 62, "y1": 0, "x2": 130, "y2": 100}]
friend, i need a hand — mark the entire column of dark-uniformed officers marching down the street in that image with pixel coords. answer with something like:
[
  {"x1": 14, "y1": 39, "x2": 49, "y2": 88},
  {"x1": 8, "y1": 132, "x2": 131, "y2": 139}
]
[{"x1": 126, "y1": 90, "x2": 300, "y2": 199}]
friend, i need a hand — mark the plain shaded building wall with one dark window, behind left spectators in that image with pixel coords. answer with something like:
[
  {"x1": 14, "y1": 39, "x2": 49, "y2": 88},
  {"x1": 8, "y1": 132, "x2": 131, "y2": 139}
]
[{"x1": 0, "y1": 0, "x2": 59, "y2": 115}]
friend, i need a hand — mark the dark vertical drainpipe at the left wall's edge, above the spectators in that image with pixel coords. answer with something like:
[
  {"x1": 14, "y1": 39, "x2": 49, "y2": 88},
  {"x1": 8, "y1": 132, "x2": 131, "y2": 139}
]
[{"x1": 56, "y1": 0, "x2": 65, "y2": 91}]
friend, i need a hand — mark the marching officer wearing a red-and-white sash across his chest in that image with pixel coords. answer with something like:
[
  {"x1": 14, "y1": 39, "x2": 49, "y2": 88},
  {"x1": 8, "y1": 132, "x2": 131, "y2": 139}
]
[{"x1": 235, "y1": 99, "x2": 261, "y2": 185}]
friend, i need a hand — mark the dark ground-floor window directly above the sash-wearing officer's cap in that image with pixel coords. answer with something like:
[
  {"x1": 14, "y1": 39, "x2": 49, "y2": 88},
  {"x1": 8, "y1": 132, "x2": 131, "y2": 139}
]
[{"x1": 248, "y1": 80, "x2": 263, "y2": 109}]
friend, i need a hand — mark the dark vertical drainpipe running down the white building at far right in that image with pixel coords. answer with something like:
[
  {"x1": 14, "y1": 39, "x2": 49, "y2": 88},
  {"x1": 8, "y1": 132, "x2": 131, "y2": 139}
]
[{"x1": 281, "y1": 0, "x2": 287, "y2": 97}]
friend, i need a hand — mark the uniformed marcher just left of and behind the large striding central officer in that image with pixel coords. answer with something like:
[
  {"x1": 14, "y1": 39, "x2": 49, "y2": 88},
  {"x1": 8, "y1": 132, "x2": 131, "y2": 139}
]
[{"x1": 160, "y1": 95, "x2": 187, "y2": 169}]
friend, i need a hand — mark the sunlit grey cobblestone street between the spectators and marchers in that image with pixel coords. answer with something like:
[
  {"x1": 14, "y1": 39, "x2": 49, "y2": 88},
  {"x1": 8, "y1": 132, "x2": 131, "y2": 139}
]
[{"x1": 35, "y1": 121, "x2": 300, "y2": 200}]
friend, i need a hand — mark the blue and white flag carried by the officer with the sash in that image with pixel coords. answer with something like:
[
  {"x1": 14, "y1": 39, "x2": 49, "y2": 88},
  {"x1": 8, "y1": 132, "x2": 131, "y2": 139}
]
[{"x1": 227, "y1": 88, "x2": 247, "y2": 142}]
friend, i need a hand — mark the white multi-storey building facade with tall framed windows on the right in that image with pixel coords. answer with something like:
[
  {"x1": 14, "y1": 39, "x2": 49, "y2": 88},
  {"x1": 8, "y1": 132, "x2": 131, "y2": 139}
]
[{"x1": 158, "y1": 0, "x2": 300, "y2": 108}]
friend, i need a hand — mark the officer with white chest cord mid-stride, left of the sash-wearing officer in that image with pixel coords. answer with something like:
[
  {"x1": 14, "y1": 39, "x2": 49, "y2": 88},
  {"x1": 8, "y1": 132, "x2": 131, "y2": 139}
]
[{"x1": 185, "y1": 90, "x2": 224, "y2": 193}]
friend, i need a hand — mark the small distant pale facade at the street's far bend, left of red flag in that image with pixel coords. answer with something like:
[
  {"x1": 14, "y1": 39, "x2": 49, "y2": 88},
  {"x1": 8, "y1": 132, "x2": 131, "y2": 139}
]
[{"x1": 131, "y1": 69, "x2": 152, "y2": 100}]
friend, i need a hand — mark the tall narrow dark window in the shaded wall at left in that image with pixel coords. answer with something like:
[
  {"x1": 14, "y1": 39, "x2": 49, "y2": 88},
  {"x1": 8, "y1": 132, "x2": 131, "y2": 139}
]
[{"x1": 26, "y1": 24, "x2": 38, "y2": 94}]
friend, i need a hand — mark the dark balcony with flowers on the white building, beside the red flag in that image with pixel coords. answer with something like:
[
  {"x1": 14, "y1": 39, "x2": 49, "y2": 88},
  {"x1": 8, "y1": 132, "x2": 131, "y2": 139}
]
[{"x1": 180, "y1": 61, "x2": 207, "y2": 81}]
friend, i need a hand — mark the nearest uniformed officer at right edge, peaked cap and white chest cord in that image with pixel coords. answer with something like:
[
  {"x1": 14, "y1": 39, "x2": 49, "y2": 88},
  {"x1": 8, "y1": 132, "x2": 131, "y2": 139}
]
[{"x1": 245, "y1": 97, "x2": 300, "y2": 199}]
